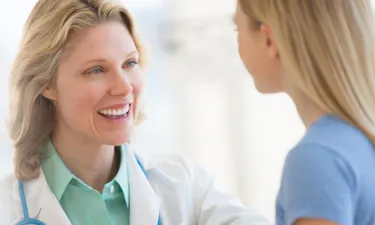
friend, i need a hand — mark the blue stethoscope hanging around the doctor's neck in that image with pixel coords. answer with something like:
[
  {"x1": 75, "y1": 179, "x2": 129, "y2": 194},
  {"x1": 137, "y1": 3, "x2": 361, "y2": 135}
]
[{"x1": 16, "y1": 156, "x2": 162, "y2": 225}]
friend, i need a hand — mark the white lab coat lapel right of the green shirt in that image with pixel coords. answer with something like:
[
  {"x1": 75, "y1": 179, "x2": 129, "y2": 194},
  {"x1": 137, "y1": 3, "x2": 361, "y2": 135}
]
[{"x1": 126, "y1": 146, "x2": 160, "y2": 225}]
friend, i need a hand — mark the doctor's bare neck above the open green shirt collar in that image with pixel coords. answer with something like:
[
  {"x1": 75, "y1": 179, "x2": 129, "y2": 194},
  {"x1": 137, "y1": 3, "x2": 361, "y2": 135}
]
[{"x1": 52, "y1": 120, "x2": 119, "y2": 192}]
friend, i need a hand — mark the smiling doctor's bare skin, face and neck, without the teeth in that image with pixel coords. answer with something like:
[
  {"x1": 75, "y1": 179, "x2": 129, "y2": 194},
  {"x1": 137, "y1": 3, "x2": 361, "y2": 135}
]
[{"x1": 43, "y1": 22, "x2": 144, "y2": 192}]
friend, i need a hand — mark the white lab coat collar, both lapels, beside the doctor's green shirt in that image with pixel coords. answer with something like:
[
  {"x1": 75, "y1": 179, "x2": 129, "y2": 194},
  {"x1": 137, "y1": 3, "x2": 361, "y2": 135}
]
[{"x1": 13, "y1": 146, "x2": 160, "y2": 225}]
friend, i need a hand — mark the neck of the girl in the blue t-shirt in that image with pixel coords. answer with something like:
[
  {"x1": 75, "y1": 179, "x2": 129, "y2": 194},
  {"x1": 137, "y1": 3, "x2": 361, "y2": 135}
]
[{"x1": 288, "y1": 89, "x2": 326, "y2": 128}]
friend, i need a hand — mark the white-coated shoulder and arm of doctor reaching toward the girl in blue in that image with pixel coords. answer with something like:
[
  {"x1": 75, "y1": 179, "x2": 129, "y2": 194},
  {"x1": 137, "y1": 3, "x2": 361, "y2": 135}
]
[{"x1": 131, "y1": 152, "x2": 269, "y2": 224}]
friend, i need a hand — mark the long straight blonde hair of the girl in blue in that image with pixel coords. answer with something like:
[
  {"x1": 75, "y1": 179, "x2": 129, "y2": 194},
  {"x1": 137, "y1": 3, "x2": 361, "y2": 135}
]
[{"x1": 239, "y1": 0, "x2": 375, "y2": 143}]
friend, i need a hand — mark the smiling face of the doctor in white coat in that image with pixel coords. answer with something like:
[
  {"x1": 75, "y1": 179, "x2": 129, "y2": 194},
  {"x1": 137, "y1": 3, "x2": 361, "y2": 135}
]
[{"x1": 43, "y1": 22, "x2": 144, "y2": 145}]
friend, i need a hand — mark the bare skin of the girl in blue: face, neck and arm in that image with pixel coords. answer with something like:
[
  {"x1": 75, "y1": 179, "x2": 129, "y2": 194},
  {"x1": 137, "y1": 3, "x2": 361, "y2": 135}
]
[{"x1": 234, "y1": 1, "x2": 336, "y2": 225}]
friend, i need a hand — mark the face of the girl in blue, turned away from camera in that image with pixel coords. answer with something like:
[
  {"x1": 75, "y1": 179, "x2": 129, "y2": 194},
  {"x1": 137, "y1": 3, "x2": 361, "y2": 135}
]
[{"x1": 234, "y1": 2, "x2": 283, "y2": 93}]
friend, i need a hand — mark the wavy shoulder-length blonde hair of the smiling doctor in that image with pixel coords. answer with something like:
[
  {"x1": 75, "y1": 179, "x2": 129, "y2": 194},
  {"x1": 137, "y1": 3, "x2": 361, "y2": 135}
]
[{"x1": 8, "y1": 0, "x2": 145, "y2": 180}]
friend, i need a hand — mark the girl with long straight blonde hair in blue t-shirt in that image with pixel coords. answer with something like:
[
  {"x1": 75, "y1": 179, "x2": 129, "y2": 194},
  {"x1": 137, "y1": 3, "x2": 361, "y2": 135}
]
[{"x1": 235, "y1": 0, "x2": 375, "y2": 225}]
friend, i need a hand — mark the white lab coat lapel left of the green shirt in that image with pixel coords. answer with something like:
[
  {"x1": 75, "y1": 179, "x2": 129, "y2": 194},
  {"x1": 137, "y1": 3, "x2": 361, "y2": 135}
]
[{"x1": 13, "y1": 172, "x2": 71, "y2": 225}]
